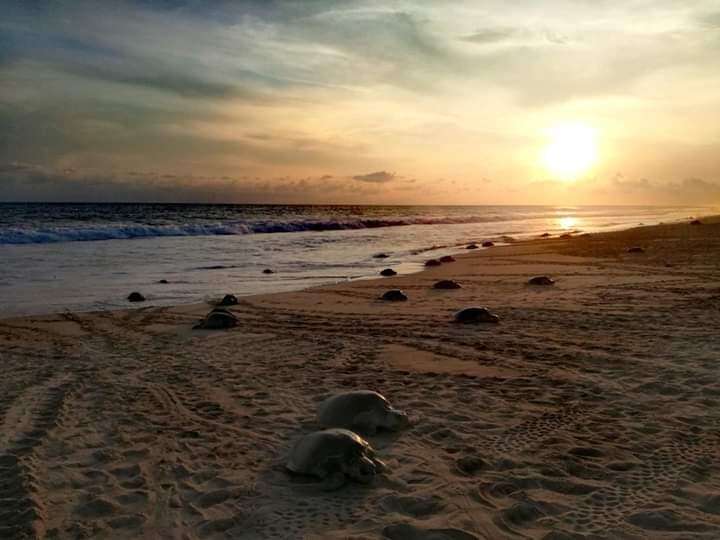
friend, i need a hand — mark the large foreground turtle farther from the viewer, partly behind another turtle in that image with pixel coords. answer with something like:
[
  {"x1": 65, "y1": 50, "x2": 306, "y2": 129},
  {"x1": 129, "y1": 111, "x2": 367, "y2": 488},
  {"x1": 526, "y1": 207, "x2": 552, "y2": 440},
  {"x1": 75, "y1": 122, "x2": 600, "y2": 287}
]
[{"x1": 318, "y1": 390, "x2": 408, "y2": 435}]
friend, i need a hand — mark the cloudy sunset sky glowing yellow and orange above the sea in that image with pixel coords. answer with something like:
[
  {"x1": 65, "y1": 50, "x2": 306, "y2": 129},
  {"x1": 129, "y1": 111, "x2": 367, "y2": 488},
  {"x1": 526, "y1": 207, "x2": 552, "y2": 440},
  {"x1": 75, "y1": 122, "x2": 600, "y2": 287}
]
[{"x1": 0, "y1": 0, "x2": 720, "y2": 204}]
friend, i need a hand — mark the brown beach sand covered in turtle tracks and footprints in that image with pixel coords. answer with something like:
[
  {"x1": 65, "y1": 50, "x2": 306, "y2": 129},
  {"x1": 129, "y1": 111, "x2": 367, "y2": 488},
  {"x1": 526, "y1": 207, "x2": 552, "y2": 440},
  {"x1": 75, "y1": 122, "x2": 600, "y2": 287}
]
[{"x1": 0, "y1": 217, "x2": 720, "y2": 540}]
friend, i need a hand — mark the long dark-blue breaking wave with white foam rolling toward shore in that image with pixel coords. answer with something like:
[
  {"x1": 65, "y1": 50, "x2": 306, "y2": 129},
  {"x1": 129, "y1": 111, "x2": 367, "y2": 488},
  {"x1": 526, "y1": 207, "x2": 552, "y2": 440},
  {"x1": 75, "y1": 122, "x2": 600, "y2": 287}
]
[{"x1": 0, "y1": 216, "x2": 507, "y2": 245}]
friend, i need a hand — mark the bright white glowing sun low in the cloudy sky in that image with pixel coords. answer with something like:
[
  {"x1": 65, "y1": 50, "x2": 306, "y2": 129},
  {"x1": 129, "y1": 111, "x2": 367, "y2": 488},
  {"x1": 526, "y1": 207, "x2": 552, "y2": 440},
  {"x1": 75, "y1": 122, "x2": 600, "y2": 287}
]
[{"x1": 542, "y1": 122, "x2": 598, "y2": 181}]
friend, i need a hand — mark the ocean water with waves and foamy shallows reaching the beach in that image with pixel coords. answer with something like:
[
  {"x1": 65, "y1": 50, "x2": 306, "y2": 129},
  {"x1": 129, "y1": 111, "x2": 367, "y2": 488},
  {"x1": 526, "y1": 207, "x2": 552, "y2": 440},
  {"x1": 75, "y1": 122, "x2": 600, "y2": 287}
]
[{"x1": 0, "y1": 203, "x2": 709, "y2": 317}]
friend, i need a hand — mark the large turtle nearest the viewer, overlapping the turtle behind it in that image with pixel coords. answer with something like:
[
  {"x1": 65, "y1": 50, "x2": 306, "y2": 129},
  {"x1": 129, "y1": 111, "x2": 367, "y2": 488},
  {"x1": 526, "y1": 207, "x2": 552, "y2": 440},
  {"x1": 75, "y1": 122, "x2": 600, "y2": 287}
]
[{"x1": 285, "y1": 428, "x2": 385, "y2": 491}]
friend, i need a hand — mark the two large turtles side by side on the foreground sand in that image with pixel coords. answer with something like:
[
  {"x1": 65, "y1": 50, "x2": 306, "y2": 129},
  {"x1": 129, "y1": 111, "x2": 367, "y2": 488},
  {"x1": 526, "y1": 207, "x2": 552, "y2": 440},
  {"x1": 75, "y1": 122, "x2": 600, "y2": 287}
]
[{"x1": 285, "y1": 390, "x2": 409, "y2": 491}]
